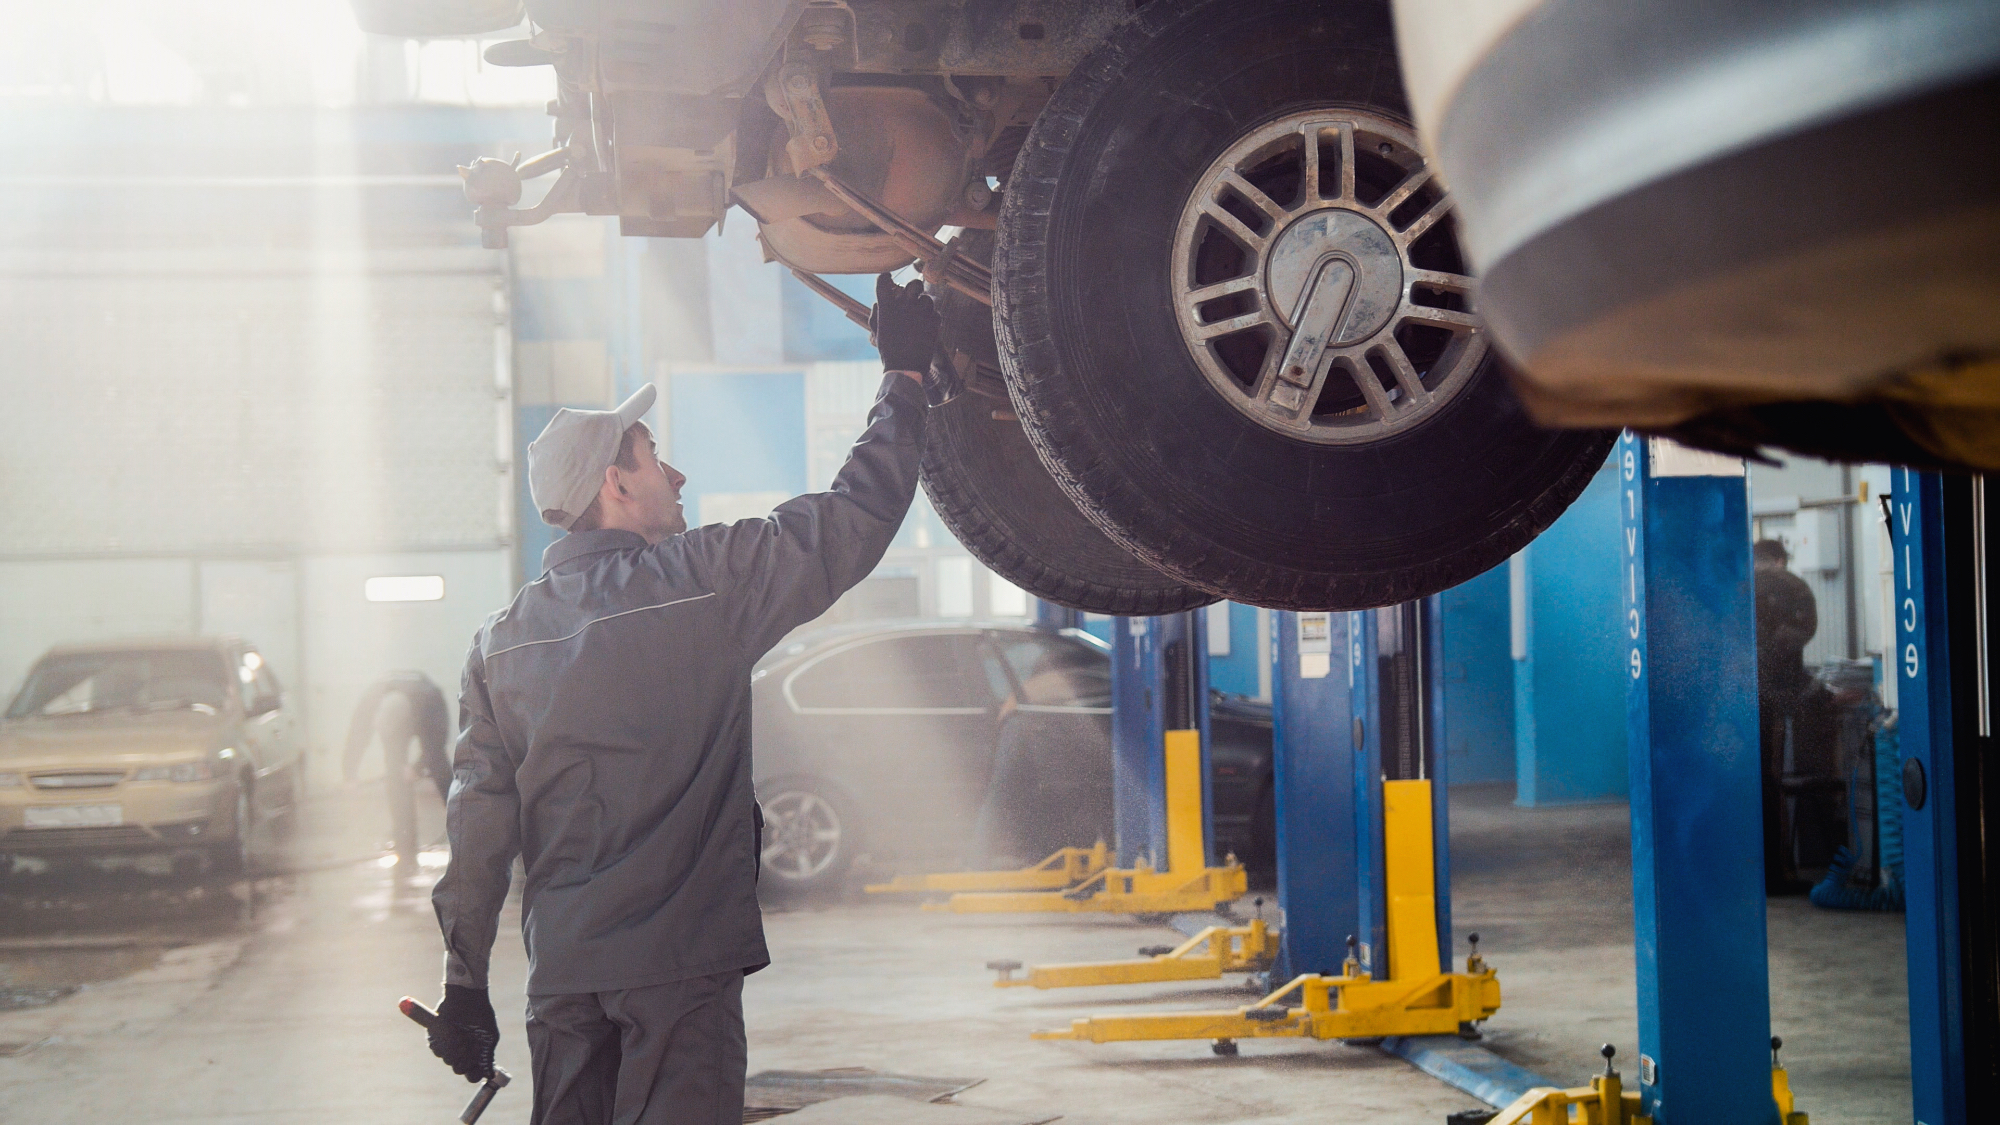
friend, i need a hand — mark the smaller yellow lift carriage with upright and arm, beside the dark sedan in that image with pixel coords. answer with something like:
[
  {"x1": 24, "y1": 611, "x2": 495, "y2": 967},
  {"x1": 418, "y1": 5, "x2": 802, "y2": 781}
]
[{"x1": 924, "y1": 731, "x2": 1250, "y2": 915}]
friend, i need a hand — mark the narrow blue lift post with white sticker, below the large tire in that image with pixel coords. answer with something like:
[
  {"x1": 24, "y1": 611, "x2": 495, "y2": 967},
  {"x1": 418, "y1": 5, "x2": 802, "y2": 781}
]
[{"x1": 1270, "y1": 613, "x2": 1358, "y2": 981}]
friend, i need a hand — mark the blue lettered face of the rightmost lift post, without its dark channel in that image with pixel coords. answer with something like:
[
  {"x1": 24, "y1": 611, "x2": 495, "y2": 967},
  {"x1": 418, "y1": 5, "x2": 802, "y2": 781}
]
[{"x1": 1890, "y1": 468, "x2": 1972, "y2": 1125}]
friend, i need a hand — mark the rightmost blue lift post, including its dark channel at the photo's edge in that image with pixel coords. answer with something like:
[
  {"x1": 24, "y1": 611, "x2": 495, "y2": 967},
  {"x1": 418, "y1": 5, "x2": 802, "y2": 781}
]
[{"x1": 1886, "y1": 468, "x2": 2000, "y2": 1125}]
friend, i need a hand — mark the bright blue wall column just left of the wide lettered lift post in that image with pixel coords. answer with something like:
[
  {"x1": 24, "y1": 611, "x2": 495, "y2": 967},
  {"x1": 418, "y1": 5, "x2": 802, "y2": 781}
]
[{"x1": 1510, "y1": 462, "x2": 1628, "y2": 805}]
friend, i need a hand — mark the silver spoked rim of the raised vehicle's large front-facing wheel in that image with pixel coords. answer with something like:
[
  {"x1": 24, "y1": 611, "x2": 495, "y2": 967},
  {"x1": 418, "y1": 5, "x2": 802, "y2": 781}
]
[{"x1": 1172, "y1": 110, "x2": 1486, "y2": 444}]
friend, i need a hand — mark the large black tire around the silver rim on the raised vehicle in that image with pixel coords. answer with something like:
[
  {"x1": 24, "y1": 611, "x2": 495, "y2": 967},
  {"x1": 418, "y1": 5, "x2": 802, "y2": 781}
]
[{"x1": 994, "y1": 0, "x2": 1614, "y2": 611}]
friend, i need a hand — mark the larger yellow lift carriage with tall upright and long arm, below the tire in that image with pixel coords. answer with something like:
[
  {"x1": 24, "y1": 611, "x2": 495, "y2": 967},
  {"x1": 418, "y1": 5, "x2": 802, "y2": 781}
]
[{"x1": 1034, "y1": 781, "x2": 1500, "y2": 1055}]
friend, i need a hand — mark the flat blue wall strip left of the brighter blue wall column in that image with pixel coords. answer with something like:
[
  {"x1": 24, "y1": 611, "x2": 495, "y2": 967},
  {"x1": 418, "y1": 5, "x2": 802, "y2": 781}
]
[{"x1": 1438, "y1": 565, "x2": 1514, "y2": 785}]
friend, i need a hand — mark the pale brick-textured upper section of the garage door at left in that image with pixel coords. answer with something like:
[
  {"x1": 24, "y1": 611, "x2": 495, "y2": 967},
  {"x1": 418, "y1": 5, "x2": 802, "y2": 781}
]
[{"x1": 0, "y1": 258, "x2": 506, "y2": 556}]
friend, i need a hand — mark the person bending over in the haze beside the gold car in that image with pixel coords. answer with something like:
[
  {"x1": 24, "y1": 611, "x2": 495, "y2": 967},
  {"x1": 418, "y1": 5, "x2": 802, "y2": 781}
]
[{"x1": 340, "y1": 671, "x2": 452, "y2": 860}]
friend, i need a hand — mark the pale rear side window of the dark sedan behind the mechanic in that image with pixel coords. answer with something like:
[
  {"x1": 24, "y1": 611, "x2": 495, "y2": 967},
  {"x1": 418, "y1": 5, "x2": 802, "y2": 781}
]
[{"x1": 788, "y1": 635, "x2": 990, "y2": 711}]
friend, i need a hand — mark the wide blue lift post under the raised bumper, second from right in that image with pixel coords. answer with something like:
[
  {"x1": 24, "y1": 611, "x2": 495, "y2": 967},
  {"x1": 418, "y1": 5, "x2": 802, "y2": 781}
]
[{"x1": 1618, "y1": 432, "x2": 1778, "y2": 1125}]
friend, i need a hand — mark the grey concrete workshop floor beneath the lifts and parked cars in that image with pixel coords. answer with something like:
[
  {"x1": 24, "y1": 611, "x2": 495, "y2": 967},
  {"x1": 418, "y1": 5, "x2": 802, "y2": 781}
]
[{"x1": 0, "y1": 787, "x2": 1910, "y2": 1125}]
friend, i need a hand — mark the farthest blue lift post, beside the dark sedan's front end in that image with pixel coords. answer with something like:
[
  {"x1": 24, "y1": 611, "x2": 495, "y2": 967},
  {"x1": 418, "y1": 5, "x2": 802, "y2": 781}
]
[{"x1": 1112, "y1": 611, "x2": 1214, "y2": 871}]
